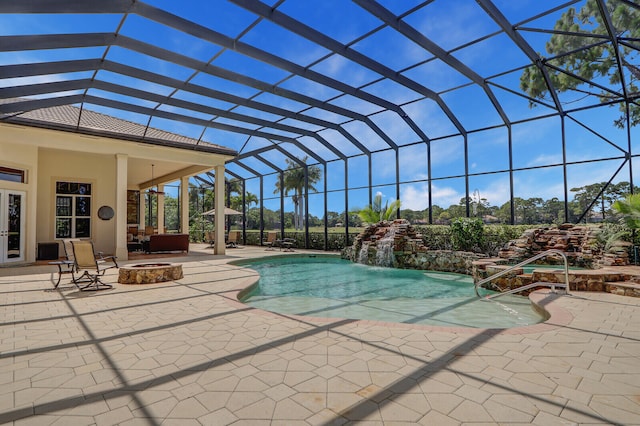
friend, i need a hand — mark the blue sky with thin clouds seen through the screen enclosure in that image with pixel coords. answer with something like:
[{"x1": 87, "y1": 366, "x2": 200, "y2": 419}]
[{"x1": 0, "y1": 0, "x2": 638, "y2": 216}]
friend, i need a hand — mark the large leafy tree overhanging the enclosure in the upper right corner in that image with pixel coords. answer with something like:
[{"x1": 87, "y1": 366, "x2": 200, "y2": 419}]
[{"x1": 520, "y1": 0, "x2": 640, "y2": 128}]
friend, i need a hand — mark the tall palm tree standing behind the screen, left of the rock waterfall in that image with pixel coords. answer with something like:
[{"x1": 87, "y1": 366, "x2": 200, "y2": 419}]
[{"x1": 273, "y1": 157, "x2": 321, "y2": 229}]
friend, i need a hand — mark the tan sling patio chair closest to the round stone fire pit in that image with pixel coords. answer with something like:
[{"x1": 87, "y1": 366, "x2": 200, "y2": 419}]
[{"x1": 71, "y1": 240, "x2": 118, "y2": 291}]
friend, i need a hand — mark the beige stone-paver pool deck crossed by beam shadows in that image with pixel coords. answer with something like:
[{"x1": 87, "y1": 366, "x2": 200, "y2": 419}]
[{"x1": 0, "y1": 245, "x2": 640, "y2": 426}]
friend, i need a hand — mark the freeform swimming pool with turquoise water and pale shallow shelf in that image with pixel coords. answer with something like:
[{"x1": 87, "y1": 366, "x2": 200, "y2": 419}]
[{"x1": 239, "y1": 256, "x2": 544, "y2": 328}]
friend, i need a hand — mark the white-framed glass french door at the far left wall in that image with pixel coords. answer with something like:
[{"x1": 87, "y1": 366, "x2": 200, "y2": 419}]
[{"x1": 0, "y1": 189, "x2": 26, "y2": 263}]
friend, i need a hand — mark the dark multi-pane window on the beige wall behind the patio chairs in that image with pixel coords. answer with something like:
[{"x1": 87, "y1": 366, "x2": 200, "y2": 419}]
[{"x1": 55, "y1": 182, "x2": 91, "y2": 238}]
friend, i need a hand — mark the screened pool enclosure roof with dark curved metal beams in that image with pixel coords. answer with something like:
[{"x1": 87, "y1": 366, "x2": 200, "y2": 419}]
[{"x1": 0, "y1": 0, "x2": 640, "y2": 213}]
